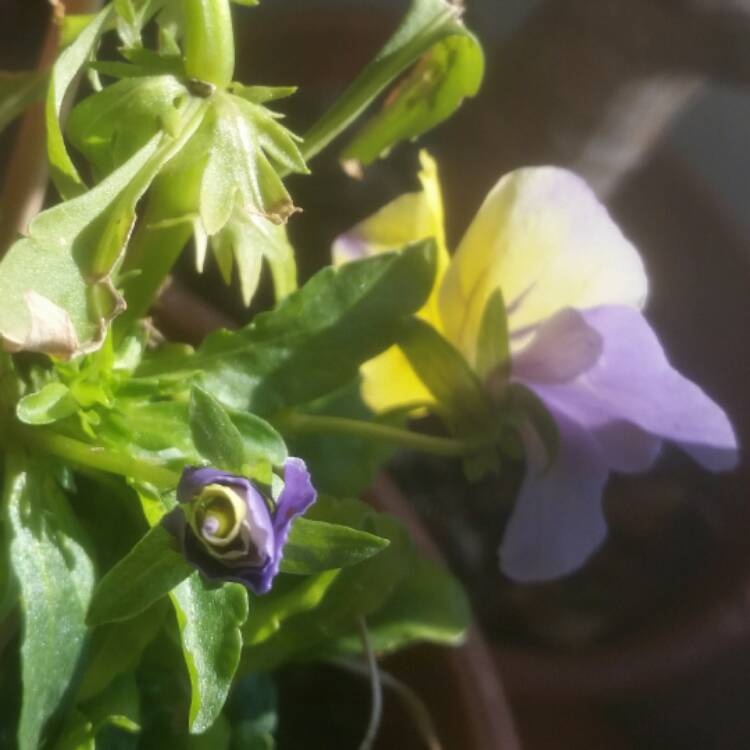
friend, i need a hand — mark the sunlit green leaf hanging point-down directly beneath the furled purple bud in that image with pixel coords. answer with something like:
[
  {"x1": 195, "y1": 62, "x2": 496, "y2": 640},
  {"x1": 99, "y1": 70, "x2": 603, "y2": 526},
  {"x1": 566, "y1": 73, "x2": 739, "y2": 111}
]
[{"x1": 170, "y1": 572, "x2": 248, "y2": 734}]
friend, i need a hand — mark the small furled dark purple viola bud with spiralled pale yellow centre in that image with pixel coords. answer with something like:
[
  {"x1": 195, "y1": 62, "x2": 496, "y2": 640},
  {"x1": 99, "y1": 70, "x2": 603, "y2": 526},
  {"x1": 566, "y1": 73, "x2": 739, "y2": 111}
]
[{"x1": 168, "y1": 458, "x2": 316, "y2": 594}]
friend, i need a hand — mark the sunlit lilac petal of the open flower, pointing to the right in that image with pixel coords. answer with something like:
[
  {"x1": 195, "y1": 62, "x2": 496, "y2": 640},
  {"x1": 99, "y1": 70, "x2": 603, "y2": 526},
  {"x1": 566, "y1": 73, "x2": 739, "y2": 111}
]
[{"x1": 514, "y1": 305, "x2": 738, "y2": 471}]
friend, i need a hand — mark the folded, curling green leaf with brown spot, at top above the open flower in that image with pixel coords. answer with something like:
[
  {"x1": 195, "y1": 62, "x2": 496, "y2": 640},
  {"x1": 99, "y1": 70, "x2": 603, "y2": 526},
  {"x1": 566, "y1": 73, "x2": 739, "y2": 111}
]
[{"x1": 302, "y1": 0, "x2": 484, "y2": 161}]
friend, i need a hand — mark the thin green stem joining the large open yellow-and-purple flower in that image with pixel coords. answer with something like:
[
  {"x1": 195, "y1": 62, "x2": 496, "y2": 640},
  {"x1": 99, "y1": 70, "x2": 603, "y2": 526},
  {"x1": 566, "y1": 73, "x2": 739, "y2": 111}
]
[{"x1": 276, "y1": 413, "x2": 486, "y2": 456}]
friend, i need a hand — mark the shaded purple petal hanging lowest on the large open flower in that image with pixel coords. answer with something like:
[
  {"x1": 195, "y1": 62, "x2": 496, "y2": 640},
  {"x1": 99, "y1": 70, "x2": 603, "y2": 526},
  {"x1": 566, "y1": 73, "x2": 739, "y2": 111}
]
[{"x1": 500, "y1": 411, "x2": 609, "y2": 582}]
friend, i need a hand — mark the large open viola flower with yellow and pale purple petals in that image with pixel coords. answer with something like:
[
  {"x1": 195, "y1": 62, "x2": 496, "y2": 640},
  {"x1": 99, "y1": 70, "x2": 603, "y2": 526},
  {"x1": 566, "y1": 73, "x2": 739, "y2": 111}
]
[{"x1": 333, "y1": 154, "x2": 738, "y2": 581}]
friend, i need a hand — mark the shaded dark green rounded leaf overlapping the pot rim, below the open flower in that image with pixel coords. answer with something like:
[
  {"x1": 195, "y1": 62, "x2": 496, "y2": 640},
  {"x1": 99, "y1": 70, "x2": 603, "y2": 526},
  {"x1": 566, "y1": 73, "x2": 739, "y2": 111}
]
[{"x1": 321, "y1": 558, "x2": 471, "y2": 654}]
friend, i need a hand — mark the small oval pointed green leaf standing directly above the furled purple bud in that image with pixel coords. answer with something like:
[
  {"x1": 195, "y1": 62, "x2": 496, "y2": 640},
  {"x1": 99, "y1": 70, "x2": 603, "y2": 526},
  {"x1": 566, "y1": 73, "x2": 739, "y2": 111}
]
[{"x1": 190, "y1": 387, "x2": 245, "y2": 473}]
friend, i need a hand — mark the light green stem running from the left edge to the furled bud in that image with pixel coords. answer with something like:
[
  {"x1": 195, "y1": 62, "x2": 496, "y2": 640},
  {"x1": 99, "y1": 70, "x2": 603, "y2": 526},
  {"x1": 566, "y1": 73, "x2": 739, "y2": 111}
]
[{"x1": 23, "y1": 429, "x2": 180, "y2": 487}]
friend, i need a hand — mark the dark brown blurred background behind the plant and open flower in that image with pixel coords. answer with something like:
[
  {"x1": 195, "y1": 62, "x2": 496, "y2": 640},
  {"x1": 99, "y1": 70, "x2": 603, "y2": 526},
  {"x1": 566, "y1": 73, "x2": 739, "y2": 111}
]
[{"x1": 0, "y1": 0, "x2": 750, "y2": 750}]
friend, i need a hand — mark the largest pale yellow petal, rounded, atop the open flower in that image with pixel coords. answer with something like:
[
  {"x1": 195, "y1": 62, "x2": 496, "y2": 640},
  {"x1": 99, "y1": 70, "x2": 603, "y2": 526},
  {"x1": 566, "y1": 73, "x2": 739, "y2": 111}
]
[{"x1": 440, "y1": 167, "x2": 648, "y2": 362}]
